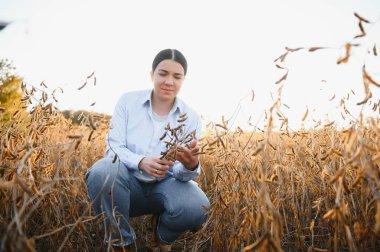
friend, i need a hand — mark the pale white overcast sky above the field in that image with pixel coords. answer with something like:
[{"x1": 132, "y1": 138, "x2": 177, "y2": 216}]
[{"x1": 0, "y1": 0, "x2": 380, "y2": 129}]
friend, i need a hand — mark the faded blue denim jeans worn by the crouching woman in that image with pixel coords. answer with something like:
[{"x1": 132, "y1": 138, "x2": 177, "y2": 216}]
[{"x1": 86, "y1": 158, "x2": 210, "y2": 245}]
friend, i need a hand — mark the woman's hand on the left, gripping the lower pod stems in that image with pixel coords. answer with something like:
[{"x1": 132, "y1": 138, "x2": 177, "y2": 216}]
[{"x1": 139, "y1": 157, "x2": 174, "y2": 178}]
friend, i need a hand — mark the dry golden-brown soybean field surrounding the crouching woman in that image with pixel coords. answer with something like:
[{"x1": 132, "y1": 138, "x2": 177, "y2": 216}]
[{"x1": 0, "y1": 14, "x2": 380, "y2": 251}]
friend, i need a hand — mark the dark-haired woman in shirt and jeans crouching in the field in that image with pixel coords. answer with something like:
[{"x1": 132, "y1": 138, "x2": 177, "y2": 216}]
[{"x1": 86, "y1": 49, "x2": 210, "y2": 251}]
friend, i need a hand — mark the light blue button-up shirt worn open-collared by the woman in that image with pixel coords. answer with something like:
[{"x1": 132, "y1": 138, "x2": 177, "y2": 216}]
[{"x1": 105, "y1": 90, "x2": 202, "y2": 182}]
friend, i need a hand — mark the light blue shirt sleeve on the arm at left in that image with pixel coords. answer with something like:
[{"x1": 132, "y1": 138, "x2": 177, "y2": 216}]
[{"x1": 105, "y1": 98, "x2": 144, "y2": 170}]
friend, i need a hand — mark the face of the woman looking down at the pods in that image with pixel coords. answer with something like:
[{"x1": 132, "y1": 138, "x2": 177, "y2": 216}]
[{"x1": 150, "y1": 60, "x2": 185, "y2": 101}]
